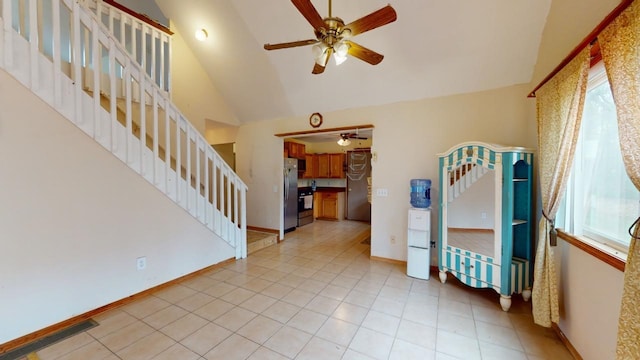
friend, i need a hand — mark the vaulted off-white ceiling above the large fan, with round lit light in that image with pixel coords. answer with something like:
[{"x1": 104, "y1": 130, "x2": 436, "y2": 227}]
[{"x1": 156, "y1": 0, "x2": 551, "y2": 123}]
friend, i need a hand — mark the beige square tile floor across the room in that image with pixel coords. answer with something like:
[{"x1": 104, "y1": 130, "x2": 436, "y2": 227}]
[{"x1": 25, "y1": 221, "x2": 571, "y2": 360}]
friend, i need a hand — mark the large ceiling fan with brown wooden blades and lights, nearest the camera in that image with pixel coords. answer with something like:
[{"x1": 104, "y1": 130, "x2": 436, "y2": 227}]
[{"x1": 264, "y1": 0, "x2": 397, "y2": 74}]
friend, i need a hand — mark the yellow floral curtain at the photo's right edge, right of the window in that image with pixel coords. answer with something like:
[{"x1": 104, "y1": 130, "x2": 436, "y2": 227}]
[{"x1": 598, "y1": 1, "x2": 640, "y2": 359}]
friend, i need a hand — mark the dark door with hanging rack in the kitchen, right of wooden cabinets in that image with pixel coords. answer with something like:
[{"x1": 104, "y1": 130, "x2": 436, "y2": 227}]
[{"x1": 347, "y1": 150, "x2": 371, "y2": 222}]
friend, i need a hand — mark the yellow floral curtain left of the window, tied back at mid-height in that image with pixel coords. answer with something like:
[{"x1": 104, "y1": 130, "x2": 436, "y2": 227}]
[{"x1": 532, "y1": 46, "x2": 590, "y2": 327}]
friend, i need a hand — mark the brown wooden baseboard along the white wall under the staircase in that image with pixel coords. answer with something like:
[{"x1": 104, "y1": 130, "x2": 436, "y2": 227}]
[{"x1": 0, "y1": 258, "x2": 236, "y2": 354}]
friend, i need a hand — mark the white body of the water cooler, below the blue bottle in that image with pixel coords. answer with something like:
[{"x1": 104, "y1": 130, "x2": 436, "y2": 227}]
[{"x1": 407, "y1": 208, "x2": 431, "y2": 280}]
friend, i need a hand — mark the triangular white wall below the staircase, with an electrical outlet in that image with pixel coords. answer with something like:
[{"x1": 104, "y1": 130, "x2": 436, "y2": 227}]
[{"x1": 0, "y1": 70, "x2": 235, "y2": 344}]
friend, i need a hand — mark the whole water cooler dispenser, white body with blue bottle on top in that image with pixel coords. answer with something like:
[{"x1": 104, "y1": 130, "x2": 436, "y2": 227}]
[{"x1": 407, "y1": 179, "x2": 431, "y2": 280}]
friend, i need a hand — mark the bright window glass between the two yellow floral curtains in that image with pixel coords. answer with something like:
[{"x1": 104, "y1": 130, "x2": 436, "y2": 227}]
[{"x1": 558, "y1": 63, "x2": 640, "y2": 252}]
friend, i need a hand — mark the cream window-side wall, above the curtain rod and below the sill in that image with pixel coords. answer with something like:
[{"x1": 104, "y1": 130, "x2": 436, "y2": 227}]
[{"x1": 530, "y1": 0, "x2": 623, "y2": 360}]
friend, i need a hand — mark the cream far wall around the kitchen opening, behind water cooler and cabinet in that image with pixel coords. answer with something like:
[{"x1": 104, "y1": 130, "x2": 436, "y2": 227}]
[{"x1": 236, "y1": 86, "x2": 535, "y2": 248}]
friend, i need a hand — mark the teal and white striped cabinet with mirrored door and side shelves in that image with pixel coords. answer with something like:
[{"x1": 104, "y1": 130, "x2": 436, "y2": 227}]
[{"x1": 438, "y1": 142, "x2": 534, "y2": 311}]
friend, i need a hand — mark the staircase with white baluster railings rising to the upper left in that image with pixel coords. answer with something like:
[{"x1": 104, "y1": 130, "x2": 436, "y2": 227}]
[{"x1": 0, "y1": 0, "x2": 247, "y2": 258}]
